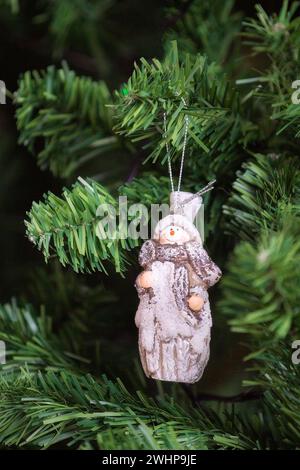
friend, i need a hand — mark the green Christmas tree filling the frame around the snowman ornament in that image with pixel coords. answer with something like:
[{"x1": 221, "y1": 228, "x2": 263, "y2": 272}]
[{"x1": 0, "y1": 0, "x2": 300, "y2": 450}]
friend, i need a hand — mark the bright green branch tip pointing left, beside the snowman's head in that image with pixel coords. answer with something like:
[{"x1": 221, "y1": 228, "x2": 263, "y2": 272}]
[{"x1": 26, "y1": 180, "x2": 138, "y2": 273}]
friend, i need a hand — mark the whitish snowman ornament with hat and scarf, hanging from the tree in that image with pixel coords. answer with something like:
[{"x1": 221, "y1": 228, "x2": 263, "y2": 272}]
[{"x1": 135, "y1": 191, "x2": 221, "y2": 383}]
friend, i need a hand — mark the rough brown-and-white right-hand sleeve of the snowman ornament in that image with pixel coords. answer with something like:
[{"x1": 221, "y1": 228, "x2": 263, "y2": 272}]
[{"x1": 186, "y1": 242, "x2": 222, "y2": 287}]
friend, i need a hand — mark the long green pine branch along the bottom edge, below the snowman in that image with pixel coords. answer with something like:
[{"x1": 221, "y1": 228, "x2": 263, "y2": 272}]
[{"x1": 0, "y1": 370, "x2": 264, "y2": 449}]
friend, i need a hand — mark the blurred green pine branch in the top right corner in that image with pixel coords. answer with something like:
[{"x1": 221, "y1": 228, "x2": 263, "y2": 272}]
[{"x1": 243, "y1": 0, "x2": 300, "y2": 136}]
